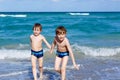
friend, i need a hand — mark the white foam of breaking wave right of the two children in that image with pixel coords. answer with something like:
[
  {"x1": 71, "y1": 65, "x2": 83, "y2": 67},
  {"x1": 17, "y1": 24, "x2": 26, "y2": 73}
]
[{"x1": 72, "y1": 44, "x2": 120, "y2": 56}]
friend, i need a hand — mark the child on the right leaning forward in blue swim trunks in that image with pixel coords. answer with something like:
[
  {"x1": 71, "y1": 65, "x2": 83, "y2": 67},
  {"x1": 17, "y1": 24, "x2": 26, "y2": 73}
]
[{"x1": 50, "y1": 26, "x2": 79, "y2": 80}]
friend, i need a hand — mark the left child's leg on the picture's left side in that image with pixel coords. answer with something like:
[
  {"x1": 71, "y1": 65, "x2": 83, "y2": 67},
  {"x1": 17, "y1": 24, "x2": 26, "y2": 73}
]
[{"x1": 31, "y1": 55, "x2": 37, "y2": 80}]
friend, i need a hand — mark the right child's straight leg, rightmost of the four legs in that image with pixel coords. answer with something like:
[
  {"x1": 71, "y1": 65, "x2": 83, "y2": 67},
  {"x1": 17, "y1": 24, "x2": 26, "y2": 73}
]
[{"x1": 61, "y1": 56, "x2": 68, "y2": 80}]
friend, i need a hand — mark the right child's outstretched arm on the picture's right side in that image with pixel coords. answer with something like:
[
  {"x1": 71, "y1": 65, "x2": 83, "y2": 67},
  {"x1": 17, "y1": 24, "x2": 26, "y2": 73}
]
[{"x1": 66, "y1": 39, "x2": 79, "y2": 70}]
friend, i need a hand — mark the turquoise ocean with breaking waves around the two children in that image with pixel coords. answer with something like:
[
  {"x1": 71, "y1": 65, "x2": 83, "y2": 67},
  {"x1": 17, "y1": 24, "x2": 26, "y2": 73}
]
[{"x1": 0, "y1": 12, "x2": 120, "y2": 80}]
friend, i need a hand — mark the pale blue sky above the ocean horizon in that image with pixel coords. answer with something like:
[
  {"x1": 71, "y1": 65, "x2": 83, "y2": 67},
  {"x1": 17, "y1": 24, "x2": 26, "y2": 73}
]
[{"x1": 0, "y1": 0, "x2": 120, "y2": 12}]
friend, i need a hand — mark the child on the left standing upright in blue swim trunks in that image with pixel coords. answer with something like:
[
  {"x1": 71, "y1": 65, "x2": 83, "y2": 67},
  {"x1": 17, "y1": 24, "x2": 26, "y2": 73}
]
[{"x1": 30, "y1": 23, "x2": 51, "y2": 80}]
